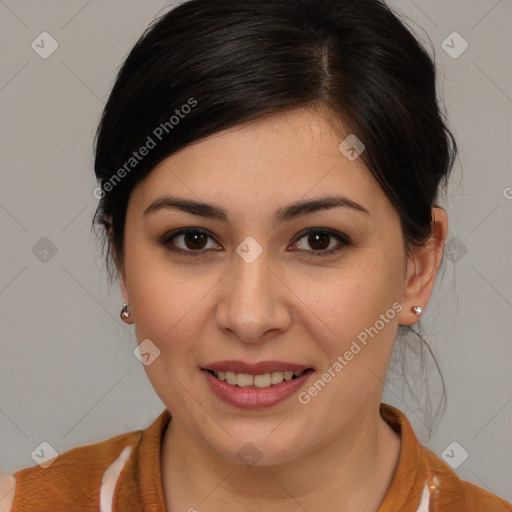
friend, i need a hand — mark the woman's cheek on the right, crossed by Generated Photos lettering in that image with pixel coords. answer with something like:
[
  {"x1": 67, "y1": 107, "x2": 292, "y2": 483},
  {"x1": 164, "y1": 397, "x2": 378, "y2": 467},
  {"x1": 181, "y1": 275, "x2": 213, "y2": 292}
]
[{"x1": 292, "y1": 264, "x2": 402, "y2": 404}]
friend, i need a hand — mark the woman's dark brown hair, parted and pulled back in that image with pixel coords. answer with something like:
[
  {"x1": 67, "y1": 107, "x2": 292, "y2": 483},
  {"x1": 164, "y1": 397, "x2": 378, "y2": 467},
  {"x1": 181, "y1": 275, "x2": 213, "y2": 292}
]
[{"x1": 91, "y1": 0, "x2": 457, "y2": 428}]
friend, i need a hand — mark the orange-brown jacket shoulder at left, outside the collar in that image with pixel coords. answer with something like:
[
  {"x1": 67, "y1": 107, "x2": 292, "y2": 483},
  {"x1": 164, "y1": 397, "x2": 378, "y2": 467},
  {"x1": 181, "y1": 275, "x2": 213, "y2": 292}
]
[{"x1": 5, "y1": 430, "x2": 143, "y2": 512}]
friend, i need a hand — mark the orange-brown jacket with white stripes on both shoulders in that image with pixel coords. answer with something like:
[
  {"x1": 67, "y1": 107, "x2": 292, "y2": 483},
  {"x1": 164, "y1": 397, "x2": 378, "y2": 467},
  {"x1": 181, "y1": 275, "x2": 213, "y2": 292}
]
[{"x1": 0, "y1": 404, "x2": 512, "y2": 512}]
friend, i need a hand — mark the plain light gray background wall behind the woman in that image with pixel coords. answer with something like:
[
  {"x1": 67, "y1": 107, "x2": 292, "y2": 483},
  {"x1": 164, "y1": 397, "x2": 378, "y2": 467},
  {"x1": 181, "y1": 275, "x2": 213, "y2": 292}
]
[{"x1": 0, "y1": 0, "x2": 512, "y2": 500}]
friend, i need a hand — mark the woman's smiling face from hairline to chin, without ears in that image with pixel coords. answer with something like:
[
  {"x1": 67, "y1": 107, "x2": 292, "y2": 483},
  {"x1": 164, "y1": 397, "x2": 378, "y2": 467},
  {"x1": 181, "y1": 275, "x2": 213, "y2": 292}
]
[{"x1": 121, "y1": 109, "x2": 420, "y2": 464}]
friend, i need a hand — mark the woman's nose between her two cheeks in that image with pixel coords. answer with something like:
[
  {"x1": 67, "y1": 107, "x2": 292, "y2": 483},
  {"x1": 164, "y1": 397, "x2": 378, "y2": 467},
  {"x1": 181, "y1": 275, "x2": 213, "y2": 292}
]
[{"x1": 213, "y1": 251, "x2": 293, "y2": 344}]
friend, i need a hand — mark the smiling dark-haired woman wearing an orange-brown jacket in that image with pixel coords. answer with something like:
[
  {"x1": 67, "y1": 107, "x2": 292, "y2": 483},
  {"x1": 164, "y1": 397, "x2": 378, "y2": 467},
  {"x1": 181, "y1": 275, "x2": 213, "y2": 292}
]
[{"x1": 2, "y1": 0, "x2": 512, "y2": 512}]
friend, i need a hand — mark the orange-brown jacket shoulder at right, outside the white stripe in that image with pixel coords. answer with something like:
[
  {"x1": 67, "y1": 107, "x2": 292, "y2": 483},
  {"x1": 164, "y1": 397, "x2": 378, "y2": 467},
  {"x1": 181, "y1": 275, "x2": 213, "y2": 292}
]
[{"x1": 421, "y1": 446, "x2": 512, "y2": 512}]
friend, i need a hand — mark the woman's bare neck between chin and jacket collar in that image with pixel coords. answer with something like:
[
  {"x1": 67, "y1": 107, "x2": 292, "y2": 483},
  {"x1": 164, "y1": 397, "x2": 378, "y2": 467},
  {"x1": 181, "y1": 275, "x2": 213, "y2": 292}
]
[{"x1": 161, "y1": 404, "x2": 400, "y2": 512}]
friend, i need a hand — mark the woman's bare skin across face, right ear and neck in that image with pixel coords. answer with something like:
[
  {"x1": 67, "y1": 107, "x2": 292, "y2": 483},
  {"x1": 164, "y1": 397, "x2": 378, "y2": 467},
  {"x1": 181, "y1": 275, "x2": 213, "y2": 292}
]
[{"x1": 118, "y1": 109, "x2": 448, "y2": 512}]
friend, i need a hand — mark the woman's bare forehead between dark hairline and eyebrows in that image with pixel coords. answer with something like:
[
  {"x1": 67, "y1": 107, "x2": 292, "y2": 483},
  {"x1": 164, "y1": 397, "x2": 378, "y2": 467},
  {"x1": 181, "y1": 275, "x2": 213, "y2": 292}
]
[{"x1": 132, "y1": 109, "x2": 390, "y2": 221}]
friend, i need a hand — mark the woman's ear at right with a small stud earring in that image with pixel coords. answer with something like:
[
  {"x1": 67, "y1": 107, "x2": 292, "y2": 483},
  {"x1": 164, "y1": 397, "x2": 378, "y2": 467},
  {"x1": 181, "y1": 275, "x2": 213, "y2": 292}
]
[{"x1": 398, "y1": 207, "x2": 448, "y2": 325}]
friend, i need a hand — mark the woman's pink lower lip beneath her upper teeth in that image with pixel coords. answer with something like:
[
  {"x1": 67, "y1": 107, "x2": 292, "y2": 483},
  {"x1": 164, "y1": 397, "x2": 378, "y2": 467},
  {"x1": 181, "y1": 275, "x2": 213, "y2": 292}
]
[{"x1": 201, "y1": 370, "x2": 313, "y2": 409}]
